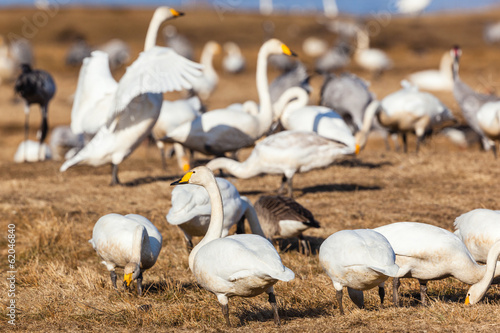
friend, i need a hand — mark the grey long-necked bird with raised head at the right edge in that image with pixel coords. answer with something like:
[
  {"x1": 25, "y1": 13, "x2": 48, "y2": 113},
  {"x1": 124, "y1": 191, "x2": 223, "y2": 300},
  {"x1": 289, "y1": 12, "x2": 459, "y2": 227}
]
[{"x1": 450, "y1": 46, "x2": 500, "y2": 156}]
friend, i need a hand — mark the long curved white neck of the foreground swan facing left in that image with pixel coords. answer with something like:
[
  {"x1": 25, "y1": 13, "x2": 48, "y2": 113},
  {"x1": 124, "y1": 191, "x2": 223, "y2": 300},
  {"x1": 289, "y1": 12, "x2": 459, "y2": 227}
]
[{"x1": 189, "y1": 173, "x2": 224, "y2": 271}]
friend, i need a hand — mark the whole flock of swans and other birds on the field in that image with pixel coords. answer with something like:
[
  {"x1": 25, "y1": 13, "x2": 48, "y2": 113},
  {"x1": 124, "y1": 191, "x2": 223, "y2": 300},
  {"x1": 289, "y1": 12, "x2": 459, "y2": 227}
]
[{"x1": 5, "y1": 1, "x2": 500, "y2": 326}]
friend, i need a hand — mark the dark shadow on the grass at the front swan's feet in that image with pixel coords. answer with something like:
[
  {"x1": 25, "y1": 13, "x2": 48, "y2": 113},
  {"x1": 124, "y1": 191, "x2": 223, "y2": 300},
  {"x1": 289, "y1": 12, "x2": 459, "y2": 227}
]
[{"x1": 236, "y1": 300, "x2": 331, "y2": 326}]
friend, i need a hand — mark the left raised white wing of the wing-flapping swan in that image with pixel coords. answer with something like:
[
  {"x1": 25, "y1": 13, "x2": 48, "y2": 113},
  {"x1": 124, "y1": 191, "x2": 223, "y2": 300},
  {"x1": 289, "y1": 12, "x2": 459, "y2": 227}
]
[{"x1": 71, "y1": 51, "x2": 118, "y2": 134}]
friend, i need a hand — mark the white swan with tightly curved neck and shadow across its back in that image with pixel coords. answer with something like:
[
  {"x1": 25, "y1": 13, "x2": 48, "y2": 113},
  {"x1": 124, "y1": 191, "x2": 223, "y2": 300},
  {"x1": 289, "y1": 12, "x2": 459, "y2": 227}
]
[{"x1": 275, "y1": 87, "x2": 359, "y2": 152}]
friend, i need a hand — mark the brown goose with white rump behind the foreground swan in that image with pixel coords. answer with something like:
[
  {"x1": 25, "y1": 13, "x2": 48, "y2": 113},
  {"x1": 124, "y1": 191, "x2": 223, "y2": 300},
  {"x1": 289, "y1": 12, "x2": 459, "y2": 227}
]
[{"x1": 254, "y1": 195, "x2": 320, "y2": 253}]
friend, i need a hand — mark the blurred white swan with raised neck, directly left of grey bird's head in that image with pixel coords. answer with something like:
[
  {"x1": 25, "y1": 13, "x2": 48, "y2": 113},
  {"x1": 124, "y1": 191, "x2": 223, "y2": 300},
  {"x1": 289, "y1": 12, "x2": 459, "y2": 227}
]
[{"x1": 408, "y1": 51, "x2": 453, "y2": 91}]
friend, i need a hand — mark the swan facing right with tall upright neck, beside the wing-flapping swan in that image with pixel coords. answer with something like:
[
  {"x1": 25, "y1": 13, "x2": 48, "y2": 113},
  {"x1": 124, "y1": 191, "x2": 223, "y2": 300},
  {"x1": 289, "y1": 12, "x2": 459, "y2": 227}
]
[{"x1": 164, "y1": 39, "x2": 293, "y2": 156}]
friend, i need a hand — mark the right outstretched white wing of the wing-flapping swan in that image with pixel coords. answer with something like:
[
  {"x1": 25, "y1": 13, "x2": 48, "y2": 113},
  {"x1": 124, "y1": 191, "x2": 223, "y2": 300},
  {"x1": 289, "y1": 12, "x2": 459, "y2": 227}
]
[{"x1": 108, "y1": 46, "x2": 203, "y2": 120}]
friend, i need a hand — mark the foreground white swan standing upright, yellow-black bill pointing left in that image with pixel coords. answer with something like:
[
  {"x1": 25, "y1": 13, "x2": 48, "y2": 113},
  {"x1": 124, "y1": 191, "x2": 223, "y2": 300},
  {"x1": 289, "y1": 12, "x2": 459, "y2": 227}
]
[{"x1": 172, "y1": 166, "x2": 295, "y2": 326}]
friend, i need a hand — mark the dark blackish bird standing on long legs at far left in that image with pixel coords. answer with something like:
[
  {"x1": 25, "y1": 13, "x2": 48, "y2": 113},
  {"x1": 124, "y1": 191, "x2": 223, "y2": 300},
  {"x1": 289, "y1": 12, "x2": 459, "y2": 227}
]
[{"x1": 14, "y1": 64, "x2": 56, "y2": 159}]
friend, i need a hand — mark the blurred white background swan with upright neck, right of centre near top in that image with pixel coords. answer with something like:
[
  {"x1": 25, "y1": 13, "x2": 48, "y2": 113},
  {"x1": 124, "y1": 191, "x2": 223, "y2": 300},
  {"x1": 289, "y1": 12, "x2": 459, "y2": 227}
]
[{"x1": 354, "y1": 29, "x2": 392, "y2": 76}]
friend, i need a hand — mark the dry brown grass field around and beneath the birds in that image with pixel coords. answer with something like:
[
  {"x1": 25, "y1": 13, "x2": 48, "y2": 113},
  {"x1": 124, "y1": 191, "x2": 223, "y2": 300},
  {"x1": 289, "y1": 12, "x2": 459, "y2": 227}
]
[{"x1": 0, "y1": 3, "x2": 500, "y2": 332}]
